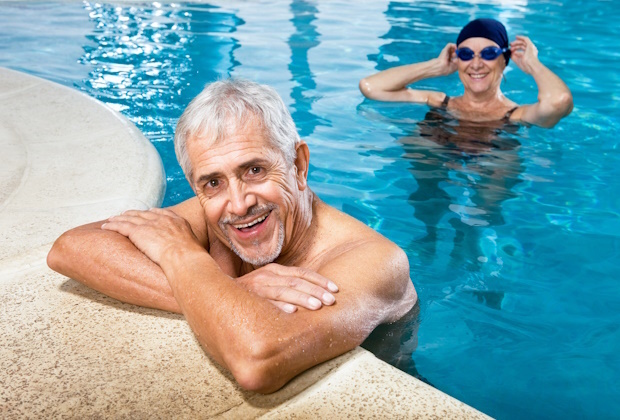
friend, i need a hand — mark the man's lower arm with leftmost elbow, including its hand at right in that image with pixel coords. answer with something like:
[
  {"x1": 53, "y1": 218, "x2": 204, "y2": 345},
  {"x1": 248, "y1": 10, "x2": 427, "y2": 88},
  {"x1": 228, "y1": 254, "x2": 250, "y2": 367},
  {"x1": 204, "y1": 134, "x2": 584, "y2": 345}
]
[{"x1": 47, "y1": 198, "x2": 338, "y2": 313}]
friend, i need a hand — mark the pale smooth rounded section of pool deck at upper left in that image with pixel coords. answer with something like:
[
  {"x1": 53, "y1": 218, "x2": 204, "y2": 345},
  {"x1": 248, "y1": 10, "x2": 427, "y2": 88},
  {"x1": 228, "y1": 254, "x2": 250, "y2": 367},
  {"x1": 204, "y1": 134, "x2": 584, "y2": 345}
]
[{"x1": 0, "y1": 69, "x2": 165, "y2": 273}]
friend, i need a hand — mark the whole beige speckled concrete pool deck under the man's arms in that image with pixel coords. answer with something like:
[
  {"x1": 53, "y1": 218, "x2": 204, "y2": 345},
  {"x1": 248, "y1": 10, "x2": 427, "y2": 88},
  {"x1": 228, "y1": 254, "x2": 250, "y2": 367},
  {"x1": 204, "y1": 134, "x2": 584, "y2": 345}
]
[{"x1": 0, "y1": 68, "x2": 488, "y2": 419}]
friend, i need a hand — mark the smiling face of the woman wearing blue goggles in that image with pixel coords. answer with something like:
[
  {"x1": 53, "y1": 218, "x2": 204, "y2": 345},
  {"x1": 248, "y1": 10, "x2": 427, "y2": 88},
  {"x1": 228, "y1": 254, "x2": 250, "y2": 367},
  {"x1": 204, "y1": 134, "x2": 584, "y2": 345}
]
[{"x1": 456, "y1": 38, "x2": 506, "y2": 94}]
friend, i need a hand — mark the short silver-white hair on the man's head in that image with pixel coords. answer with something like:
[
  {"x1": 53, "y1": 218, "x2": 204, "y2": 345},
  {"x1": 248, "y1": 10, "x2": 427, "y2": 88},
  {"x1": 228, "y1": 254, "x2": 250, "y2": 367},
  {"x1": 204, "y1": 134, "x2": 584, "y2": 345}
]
[{"x1": 174, "y1": 79, "x2": 301, "y2": 185}]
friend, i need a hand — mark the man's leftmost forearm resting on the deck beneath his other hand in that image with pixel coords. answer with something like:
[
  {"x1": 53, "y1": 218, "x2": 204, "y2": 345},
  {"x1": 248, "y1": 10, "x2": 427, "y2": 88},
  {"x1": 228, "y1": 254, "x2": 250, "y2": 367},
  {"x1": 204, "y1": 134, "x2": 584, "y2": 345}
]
[{"x1": 47, "y1": 222, "x2": 181, "y2": 313}]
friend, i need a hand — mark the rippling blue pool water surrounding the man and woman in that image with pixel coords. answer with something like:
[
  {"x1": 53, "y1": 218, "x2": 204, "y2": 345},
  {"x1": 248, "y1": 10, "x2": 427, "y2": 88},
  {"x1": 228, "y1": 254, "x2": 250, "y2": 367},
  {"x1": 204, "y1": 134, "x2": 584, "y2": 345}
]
[{"x1": 0, "y1": 0, "x2": 620, "y2": 419}]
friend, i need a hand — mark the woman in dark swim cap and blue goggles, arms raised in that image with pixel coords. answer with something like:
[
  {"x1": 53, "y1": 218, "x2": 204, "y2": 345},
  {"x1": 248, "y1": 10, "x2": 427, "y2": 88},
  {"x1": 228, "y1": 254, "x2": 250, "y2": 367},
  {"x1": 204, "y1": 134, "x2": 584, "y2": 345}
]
[{"x1": 359, "y1": 19, "x2": 573, "y2": 128}]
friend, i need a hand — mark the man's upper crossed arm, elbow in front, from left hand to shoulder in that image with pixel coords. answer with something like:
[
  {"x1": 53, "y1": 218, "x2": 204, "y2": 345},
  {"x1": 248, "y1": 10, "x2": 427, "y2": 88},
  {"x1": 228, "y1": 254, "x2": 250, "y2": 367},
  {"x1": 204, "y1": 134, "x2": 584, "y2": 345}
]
[{"x1": 104, "y1": 210, "x2": 416, "y2": 393}]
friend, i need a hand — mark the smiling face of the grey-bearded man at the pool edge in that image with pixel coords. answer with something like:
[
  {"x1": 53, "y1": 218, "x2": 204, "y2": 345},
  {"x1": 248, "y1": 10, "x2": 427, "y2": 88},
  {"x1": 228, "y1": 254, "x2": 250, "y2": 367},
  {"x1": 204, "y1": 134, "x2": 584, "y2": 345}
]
[{"x1": 188, "y1": 120, "x2": 299, "y2": 266}]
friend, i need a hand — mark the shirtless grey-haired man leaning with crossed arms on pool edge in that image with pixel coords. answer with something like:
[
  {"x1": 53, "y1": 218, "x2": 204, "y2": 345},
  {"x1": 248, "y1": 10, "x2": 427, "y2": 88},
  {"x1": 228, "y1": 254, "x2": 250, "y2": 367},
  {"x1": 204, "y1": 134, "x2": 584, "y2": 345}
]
[{"x1": 48, "y1": 80, "x2": 417, "y2": 393}]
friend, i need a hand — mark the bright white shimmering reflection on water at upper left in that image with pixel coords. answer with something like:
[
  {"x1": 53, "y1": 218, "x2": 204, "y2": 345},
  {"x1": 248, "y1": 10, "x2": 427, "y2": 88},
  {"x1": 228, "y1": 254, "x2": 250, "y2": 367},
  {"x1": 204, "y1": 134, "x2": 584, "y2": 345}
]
[{"x1": 79, "y1": 3, "x2": 192, "y2": 116}]
